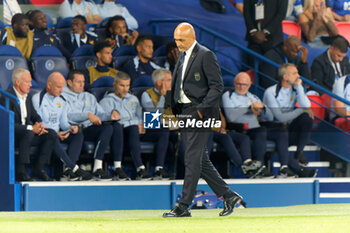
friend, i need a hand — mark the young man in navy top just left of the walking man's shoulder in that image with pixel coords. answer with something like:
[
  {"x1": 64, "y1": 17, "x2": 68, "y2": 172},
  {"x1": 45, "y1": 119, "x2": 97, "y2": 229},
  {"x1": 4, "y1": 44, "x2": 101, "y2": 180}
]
[{"x1": 121, "y1": 36, "x2": 161, "y2": 82}]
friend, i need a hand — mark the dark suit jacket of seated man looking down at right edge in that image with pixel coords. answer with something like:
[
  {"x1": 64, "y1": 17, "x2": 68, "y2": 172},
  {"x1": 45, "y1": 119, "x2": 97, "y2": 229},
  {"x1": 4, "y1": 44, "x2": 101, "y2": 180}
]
[{"x1": 311, "y1": 50, "x2": 350, "y2": 91}]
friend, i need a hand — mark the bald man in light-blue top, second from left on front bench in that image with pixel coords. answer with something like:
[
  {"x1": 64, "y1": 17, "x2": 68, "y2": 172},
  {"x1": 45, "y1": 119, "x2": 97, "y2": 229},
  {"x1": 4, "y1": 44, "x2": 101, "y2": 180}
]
[{"x1": 32, "y1": 72, "x2": 92, "y2": 180}]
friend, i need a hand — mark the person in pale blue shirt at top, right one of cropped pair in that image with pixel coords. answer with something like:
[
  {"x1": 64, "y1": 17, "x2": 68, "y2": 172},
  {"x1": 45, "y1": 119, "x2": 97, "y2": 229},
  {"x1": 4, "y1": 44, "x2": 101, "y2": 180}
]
[{"x1": 98, "y1": 0, "x2": 139, "y2": 30}]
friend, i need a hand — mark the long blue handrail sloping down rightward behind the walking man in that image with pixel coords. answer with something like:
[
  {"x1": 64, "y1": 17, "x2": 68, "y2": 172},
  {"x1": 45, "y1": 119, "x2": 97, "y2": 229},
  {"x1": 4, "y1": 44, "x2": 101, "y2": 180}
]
[{"x1": 149, "y1": 19, "x2": 350, "y2": 105}]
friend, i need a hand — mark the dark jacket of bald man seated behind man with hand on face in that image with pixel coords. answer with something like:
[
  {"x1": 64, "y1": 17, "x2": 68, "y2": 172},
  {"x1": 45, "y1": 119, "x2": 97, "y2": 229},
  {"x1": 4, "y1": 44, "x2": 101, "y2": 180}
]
[{"x1": 259, "y1": 44, "x2": 310, "y2": 88}]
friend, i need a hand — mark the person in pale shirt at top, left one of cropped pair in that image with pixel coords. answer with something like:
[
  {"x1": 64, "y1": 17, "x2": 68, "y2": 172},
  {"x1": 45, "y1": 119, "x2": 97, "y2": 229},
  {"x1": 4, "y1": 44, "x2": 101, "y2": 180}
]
[{"x1": 59, "y1": 0, "x2": 102, "y2": 24}]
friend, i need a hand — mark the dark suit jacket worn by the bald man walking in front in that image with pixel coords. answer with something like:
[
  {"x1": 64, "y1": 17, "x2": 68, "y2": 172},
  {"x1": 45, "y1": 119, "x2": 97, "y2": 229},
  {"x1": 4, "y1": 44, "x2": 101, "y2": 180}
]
[{"x1": 171, "y1": 43, "x2": 223, "y2": 118}]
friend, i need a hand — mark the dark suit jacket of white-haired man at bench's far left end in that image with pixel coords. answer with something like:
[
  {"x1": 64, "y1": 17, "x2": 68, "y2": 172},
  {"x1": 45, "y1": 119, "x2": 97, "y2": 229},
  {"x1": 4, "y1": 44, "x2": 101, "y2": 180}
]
[{"x1": 1, "y1": 88, "x2": 42, "y2": 131}]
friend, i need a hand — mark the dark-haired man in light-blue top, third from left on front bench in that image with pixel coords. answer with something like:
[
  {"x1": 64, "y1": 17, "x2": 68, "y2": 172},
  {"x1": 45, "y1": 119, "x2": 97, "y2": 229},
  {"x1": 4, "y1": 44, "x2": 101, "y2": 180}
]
[{"x1": 62, "y1": 70, "x2": 113, "y2": 180}]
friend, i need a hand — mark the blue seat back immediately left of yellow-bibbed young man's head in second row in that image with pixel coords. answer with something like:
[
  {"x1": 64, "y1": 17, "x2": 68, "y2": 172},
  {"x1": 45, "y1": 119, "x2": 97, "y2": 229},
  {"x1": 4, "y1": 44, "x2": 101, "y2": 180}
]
[{"x1": 70, "y1": 45, "x2": 96, "y2": 70}]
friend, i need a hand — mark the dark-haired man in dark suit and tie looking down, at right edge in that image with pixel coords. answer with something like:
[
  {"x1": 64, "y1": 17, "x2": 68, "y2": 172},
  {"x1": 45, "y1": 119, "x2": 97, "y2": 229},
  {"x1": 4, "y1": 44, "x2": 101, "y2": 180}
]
[{"x1": 311, "y1": 36, "x2": 350, "y2": 91}]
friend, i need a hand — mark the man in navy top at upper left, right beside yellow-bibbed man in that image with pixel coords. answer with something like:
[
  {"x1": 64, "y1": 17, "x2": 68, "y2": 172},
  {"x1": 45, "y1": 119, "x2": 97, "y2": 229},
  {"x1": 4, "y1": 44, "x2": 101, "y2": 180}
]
[{"x1": 28, "y1": 10, "x2": 70, "y2": 57}]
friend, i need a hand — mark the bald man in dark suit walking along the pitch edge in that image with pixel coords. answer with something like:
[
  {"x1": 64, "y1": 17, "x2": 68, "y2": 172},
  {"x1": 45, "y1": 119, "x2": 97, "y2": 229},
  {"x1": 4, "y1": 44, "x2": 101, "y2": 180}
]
[{"x1": 163, "y1": 23, "x2": 242, "y2": 217}]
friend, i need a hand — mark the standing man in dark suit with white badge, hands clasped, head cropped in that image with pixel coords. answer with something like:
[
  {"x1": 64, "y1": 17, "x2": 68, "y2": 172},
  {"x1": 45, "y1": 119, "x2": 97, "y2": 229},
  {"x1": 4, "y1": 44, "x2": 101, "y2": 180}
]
[{"x1": 243, "y1": 0, "x2": 288, "y2": 65}]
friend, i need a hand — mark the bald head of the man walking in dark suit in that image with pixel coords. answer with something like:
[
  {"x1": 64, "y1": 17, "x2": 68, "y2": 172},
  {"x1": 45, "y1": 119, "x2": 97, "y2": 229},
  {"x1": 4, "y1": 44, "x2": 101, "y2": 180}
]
[{"x1": 174, "y1": 23, "x2": 196, "y2": 52}]
